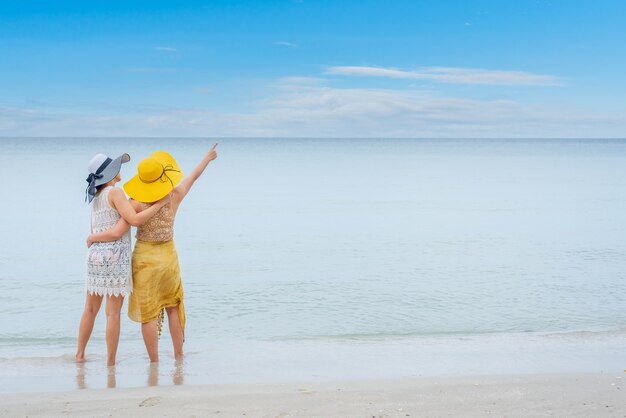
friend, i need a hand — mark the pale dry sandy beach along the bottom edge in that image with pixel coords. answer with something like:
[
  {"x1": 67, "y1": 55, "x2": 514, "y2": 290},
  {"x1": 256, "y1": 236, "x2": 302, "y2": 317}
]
[{"x1": 0, "y1": 371, "x2": 626, "y2": 417}]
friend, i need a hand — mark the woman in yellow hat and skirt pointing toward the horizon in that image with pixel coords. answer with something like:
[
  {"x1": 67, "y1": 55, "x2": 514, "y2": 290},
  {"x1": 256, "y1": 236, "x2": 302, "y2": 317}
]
[{"x1": 89, "y1": 144, "x2": 217, "y2": 362}]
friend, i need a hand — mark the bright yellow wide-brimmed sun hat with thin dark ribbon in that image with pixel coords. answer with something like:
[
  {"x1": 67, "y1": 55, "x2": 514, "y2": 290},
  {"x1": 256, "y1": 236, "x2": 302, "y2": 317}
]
[{"x1": 124, "y1": 151, "x2": 183, "y2": 203}]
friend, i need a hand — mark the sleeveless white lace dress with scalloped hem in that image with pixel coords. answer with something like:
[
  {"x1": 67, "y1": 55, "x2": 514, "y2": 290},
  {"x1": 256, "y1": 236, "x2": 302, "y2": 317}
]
[{"x1": 85, "y1": 187, "x2": 133, "y2": 296}]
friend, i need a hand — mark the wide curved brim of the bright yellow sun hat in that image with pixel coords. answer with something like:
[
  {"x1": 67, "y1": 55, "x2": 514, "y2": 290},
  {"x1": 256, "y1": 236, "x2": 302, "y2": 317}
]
[{"x1": 124, "y1": 151, "x2": 184, "y2": 203}]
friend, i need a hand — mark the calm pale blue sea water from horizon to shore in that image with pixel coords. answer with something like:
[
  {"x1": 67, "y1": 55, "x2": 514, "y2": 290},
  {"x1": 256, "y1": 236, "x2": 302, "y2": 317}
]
[{"x1": 0, "y1": 138, "x2": 626, "y2": 392}]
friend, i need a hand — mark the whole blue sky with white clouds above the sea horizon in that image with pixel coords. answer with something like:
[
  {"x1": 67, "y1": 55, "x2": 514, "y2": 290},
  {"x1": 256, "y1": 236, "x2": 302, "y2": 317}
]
[{"x1": 0, "y1": 0, "x2": 626, "y2": 138}]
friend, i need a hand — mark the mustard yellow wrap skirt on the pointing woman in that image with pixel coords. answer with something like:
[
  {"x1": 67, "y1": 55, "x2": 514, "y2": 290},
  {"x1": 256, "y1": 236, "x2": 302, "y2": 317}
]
[{"x1": 128, "y1": 240, "x2": 185, "y2": 335}]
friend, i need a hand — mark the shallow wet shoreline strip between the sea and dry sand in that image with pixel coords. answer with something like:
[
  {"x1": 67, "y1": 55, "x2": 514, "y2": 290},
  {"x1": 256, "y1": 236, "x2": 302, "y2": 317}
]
[{"x1": 0, "y1": 333, "x2": 626, "y2": 394}]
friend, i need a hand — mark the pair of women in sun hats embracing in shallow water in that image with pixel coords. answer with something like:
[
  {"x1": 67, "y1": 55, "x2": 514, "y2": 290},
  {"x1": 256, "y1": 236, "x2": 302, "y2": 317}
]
[{"x1": 76, "y1": 144, "x2": 217, "y2": 365}]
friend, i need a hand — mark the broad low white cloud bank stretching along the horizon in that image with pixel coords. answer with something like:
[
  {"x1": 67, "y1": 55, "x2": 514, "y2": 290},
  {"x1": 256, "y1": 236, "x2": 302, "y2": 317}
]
[{"x1": 0, "y1": 77, "x2": 626, "y2": 138}]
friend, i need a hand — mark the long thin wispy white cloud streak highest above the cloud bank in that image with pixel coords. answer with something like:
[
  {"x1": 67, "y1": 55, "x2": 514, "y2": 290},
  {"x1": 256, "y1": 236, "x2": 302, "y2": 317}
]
[{"x1": 326, "y1": 66, "x2": 563, "y2": 86}]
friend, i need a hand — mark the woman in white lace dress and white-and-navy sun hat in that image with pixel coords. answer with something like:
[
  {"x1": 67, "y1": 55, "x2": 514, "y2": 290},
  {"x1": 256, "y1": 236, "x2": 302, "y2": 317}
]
[{"x1": 76, "y1": 154, "x2": 169, "y2": 366}]
